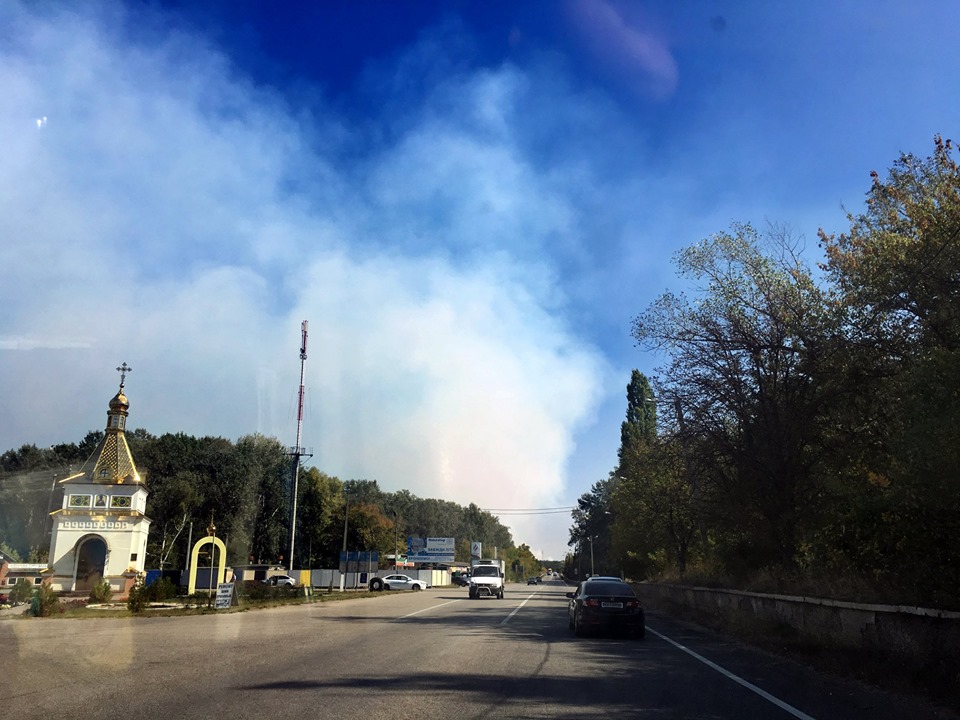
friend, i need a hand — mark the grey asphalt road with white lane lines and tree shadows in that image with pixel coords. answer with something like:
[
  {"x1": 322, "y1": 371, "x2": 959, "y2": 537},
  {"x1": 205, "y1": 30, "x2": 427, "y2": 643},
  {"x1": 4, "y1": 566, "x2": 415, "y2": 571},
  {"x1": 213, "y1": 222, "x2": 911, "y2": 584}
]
[{"x1": 0, "y1": 580, "x2": 955, "y2": 720}]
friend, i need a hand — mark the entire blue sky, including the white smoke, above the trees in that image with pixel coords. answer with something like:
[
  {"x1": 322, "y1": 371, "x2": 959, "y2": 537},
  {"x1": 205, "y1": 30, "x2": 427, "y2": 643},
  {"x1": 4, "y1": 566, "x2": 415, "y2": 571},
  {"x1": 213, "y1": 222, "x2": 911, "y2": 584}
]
[{"x1": 0, "y1": 0, "x2": 960, "y2": 558}]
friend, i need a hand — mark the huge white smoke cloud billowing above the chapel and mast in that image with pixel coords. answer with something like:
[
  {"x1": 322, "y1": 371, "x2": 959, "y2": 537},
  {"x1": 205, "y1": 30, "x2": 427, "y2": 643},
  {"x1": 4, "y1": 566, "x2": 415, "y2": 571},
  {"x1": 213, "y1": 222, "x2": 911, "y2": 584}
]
[{"x1": 0, "y1": 0, "x2": 608, "y2": 555}]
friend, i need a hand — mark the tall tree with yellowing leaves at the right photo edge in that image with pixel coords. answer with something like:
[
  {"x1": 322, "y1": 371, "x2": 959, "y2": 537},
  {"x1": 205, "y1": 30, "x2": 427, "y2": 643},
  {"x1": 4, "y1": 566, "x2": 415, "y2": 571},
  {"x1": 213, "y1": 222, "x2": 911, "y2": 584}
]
[{"x1": 813, "y1": 136, "x2": 960, "y2": 603}]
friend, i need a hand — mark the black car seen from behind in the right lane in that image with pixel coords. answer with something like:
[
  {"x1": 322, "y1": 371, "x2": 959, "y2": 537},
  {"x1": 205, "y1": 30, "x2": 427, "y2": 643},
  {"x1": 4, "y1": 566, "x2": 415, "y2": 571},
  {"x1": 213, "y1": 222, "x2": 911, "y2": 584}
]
[{"x1": 567, "y1": 578, "x2": 646, "y2": 639}]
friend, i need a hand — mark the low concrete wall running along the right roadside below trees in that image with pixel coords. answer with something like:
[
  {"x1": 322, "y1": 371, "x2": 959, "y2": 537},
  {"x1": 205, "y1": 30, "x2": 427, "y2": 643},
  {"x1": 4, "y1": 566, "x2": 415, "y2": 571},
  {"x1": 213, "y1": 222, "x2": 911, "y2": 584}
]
[{"x1": 635, "y1": 583, "x2": 960, "y2": 679}]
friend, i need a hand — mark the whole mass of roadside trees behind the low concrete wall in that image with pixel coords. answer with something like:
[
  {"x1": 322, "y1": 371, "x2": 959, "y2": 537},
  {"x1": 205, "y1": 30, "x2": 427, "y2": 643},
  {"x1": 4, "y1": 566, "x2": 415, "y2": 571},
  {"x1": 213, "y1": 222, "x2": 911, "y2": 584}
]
[{"x1": 566, "y1": 137, "x2": 960, "y2": 610}]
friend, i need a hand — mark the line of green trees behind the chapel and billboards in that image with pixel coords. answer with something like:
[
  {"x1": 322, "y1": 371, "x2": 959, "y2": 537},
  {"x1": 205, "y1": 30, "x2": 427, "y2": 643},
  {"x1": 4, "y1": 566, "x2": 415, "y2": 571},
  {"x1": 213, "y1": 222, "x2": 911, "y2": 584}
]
[{"x1": 0, "y1": 448, "x2": 516, "y2": 577}]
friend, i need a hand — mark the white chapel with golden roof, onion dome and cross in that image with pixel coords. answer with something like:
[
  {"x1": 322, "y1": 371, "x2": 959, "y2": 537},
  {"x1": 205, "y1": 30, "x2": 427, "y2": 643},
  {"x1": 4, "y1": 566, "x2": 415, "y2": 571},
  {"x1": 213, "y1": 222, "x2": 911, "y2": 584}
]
[{"x1": 45, "y1": 363, "x2": 150, "y2": 594}]
